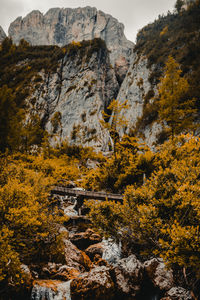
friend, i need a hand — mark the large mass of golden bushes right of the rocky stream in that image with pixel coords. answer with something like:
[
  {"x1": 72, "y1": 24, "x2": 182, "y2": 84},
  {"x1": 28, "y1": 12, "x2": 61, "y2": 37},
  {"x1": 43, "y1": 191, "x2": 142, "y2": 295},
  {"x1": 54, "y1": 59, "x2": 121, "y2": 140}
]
[{"x1": 87, "y1": 135, "x2": 200, "y2": 298}]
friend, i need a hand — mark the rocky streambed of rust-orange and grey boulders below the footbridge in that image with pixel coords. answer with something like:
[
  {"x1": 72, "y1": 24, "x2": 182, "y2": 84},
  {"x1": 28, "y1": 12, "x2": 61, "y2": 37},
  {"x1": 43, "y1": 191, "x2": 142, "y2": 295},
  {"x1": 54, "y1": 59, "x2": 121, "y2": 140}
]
[{"x1": 24, "y1": 191, "x2": 192, "y2": 300}]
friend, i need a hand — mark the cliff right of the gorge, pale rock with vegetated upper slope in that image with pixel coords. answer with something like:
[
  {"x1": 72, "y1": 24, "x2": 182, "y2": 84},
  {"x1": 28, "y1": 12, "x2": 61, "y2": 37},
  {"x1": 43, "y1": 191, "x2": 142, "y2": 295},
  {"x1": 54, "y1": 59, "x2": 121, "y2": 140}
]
[{"x1": 118, "y1": 1, "x2": 200, "y2": 145}]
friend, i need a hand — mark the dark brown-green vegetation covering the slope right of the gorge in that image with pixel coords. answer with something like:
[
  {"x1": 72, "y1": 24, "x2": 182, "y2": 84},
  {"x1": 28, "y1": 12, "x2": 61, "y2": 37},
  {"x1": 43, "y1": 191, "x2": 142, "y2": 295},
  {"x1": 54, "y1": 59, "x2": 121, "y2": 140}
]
[{"x1": 135, "y1": 0, "x2": 200, "y2": 130}]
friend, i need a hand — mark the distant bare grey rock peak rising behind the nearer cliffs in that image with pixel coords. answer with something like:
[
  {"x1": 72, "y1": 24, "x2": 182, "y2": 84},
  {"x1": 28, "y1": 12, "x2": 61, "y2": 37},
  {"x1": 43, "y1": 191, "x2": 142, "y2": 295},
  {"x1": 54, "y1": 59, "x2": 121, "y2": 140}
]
[{"x1": 9, "y1": 6, "x2": 134, "y2": 78}]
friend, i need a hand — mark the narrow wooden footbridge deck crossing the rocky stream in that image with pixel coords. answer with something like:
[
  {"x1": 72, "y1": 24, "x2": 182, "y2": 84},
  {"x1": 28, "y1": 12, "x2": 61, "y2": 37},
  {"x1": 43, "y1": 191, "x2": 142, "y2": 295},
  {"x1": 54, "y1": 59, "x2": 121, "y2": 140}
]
[{"x1": 51, "y1": 186, "x2": 123, "y2": 202}]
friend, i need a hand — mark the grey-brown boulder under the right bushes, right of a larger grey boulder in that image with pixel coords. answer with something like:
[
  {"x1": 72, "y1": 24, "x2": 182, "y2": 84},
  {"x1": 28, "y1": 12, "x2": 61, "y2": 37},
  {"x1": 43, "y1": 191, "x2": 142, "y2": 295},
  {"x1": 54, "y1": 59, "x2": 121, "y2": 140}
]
[{"x1": 144, "y1": 258, "x2": 174, "y2": 291}]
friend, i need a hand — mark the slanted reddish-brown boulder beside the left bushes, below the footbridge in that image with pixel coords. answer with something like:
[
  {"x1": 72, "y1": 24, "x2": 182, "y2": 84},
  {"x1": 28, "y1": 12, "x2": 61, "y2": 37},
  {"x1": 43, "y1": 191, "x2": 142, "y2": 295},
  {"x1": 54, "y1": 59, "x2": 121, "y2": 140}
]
[{"x1": 64, "y1": 240, "x2": 92, "y2": 272}]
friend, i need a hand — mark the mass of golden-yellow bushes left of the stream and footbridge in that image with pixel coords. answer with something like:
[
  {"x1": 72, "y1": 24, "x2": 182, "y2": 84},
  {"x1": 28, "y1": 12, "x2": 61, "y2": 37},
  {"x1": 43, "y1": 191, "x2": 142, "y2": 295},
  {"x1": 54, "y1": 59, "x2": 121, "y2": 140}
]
[{"x1": 0, "y1": 153, "x2": 79, "y2": 292}]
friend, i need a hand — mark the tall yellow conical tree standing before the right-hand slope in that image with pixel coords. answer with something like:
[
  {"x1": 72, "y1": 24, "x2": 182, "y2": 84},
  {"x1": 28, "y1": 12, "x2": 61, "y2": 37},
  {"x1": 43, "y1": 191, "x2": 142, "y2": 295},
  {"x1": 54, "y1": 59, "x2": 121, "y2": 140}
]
[{"x1": 158, "y1": 56, "x2": 197, "y2": 139}]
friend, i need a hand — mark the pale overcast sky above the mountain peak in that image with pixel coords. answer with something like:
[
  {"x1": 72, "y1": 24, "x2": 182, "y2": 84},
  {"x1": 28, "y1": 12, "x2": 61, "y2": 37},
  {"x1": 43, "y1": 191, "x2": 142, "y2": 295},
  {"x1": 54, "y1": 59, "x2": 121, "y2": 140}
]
[{"x1": 0, "y1": 0, "x2": 176, "y2": 41}]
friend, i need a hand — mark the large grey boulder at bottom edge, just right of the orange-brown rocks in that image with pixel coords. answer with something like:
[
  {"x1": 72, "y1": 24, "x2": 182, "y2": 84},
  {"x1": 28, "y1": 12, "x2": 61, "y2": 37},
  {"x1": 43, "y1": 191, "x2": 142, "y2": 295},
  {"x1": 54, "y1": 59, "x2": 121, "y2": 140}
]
[{"x1": 112, "y1": 255, "x2": 143, "y2": 297}]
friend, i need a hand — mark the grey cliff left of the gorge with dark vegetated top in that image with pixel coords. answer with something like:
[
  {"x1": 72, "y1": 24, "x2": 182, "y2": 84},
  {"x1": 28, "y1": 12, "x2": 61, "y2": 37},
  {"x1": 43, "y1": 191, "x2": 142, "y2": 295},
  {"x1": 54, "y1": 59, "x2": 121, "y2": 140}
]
[{"x1": 0, "y1": 39, "x2": 119, "y2": 149}]
